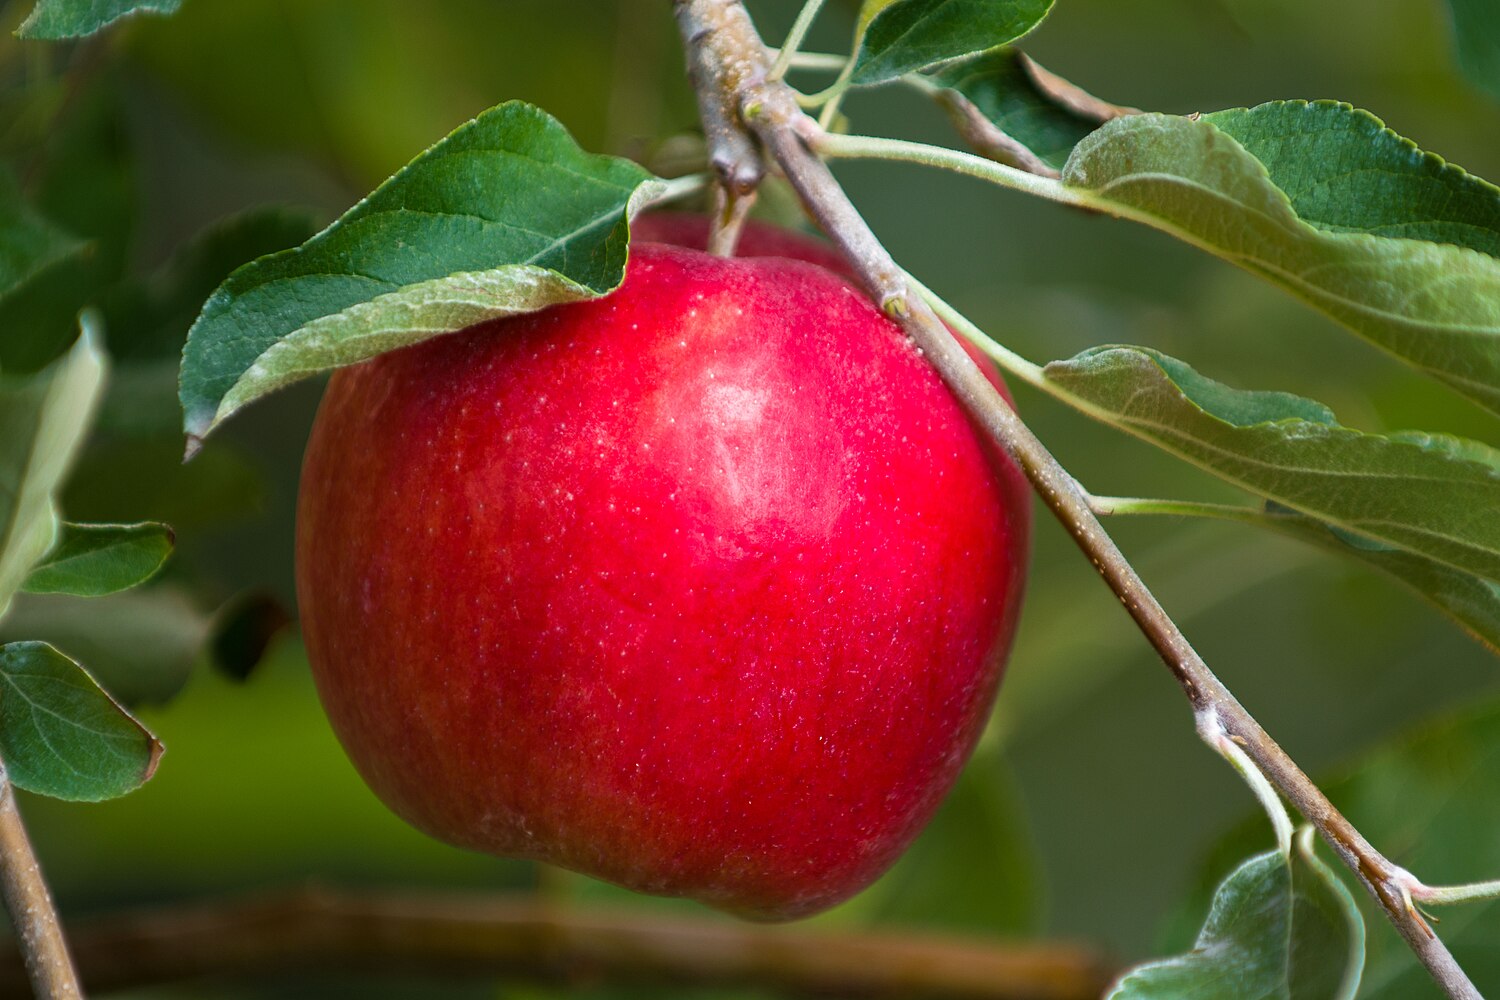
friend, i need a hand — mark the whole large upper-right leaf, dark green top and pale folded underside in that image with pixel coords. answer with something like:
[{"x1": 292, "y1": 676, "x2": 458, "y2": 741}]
[{"x1": 1062, "y1": 102, "x2": 1500, "y2": 411}]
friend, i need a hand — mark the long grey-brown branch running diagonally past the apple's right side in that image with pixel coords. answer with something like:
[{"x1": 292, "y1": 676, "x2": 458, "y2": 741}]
[{"x1": 674, "y1": 0, "x2": 1481, "y2": 1000}]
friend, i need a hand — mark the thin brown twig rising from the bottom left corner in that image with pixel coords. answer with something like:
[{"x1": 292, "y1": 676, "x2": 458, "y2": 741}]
[{"x1": 0, "y1": 763, "x2": 84, "y2": 1000}]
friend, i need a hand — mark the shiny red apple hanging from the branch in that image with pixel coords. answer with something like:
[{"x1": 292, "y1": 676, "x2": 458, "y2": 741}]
[{"x1": 297, "y1": 219, "x2": 1029, "y2": 919}]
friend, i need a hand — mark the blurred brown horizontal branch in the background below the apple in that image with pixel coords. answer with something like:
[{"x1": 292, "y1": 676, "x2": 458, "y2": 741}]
[{"x1": 0, "y1": 889, "x2": 1110, "y2": 1000}]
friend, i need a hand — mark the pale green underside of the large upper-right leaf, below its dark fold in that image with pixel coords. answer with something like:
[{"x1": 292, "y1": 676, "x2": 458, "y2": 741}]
[{"x1": 1062, "y1": 114, "x2": 1500, "y2": 411}]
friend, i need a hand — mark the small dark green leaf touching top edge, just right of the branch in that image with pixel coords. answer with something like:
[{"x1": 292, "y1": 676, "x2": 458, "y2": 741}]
[{"x1": 849, "y1": 0, "x2": 1052, "y2": 85}]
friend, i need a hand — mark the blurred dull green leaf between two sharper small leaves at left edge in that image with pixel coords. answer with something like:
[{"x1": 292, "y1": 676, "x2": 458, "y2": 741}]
[{"x1": 0, "y1": 583, "x2": 213, "y2": 706}]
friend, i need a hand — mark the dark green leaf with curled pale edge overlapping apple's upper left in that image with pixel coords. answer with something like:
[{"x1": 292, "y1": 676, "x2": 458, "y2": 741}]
[{"x1": 180, "y1": 102, "x2": 660, "y2": 438}]
